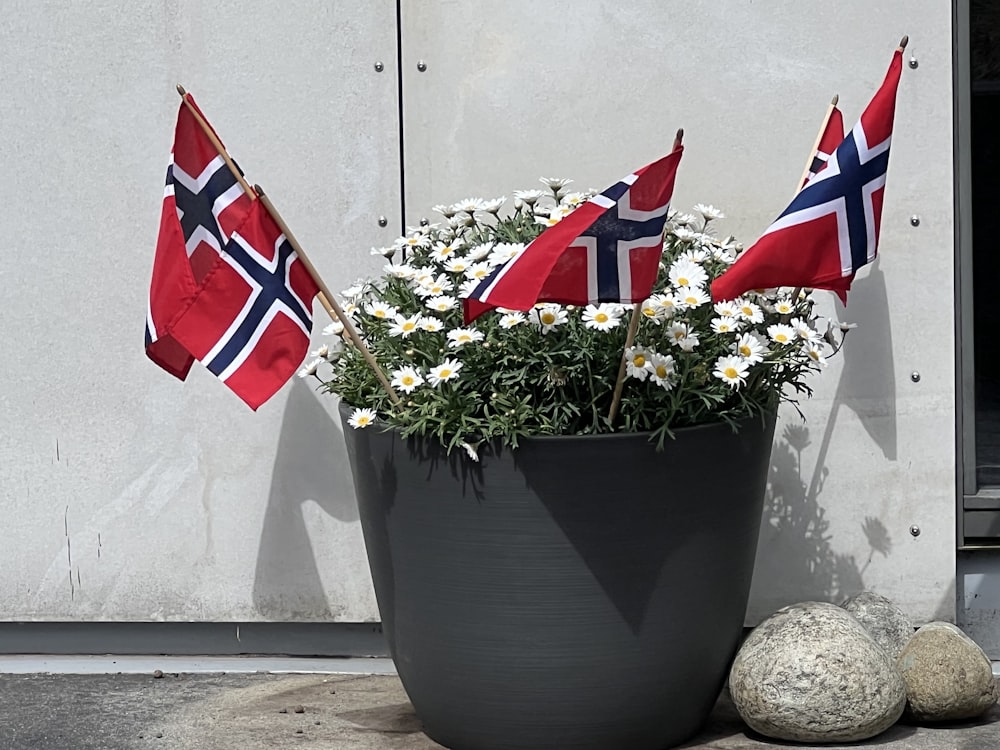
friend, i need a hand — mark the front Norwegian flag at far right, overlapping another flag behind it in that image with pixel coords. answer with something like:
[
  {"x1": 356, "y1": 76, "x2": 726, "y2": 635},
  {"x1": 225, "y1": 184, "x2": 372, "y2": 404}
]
[{"x1": 712, "y1": 49, "x2": 903, "y2": 304}]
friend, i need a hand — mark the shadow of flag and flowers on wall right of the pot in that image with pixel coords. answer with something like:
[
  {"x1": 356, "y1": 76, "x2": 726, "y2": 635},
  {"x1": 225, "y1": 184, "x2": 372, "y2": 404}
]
[{"x1": 749, "y1": 259, "x2": 896, "y2": 620}]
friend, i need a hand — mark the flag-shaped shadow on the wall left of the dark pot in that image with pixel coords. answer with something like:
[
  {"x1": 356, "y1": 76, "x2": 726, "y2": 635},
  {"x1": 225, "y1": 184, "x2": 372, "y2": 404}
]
[{"x1": 253, "y1": 378, "x2": 358, "y2": 620}]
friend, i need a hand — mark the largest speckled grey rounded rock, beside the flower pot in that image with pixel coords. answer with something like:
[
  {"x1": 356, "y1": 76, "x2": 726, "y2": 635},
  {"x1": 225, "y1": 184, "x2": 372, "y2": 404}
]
[{"x1": 729, "y1": 602, "x2": 906, "y2": 742}]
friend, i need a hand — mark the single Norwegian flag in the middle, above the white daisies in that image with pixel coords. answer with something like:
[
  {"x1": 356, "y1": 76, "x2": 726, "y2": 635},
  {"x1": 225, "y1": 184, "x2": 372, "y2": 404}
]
[{"x1": 463, "y1": 141, "x2": 684, "y2": 323}]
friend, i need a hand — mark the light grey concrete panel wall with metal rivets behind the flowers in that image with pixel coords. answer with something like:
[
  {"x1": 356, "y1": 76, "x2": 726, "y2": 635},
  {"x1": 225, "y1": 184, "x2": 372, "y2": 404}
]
[{"x1": 0, "y1": 0, "x2": 956, "y2": 622}]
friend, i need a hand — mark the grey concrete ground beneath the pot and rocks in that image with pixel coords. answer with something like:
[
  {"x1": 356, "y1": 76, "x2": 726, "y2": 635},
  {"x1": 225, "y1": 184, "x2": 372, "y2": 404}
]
[{"x1": 0, "y1": 663, "x2": 1000, "y2": 750}]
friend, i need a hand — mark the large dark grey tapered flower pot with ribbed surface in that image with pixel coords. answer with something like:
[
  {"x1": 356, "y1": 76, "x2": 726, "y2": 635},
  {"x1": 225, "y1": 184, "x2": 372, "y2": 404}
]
[{"x1": 341, "y1": 409, "x2": 774, "y2": 750}]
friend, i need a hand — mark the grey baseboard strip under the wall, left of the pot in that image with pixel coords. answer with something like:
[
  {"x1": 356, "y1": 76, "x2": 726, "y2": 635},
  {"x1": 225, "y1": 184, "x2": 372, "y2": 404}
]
[{"x1": 0, "y1": 622, "x2": 389, "y2": 657}]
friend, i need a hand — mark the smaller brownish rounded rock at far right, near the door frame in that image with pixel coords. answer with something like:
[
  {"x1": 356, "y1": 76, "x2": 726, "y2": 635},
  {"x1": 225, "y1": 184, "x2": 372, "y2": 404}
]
[{"x1": 896, "y1": 622, "x2": 998, "y2": 722}]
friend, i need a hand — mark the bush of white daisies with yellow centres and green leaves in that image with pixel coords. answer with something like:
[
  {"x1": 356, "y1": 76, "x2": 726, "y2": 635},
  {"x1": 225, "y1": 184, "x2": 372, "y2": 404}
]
[{"x1": 300, "y1": 178, "x2": 846, "y2": 458}]
